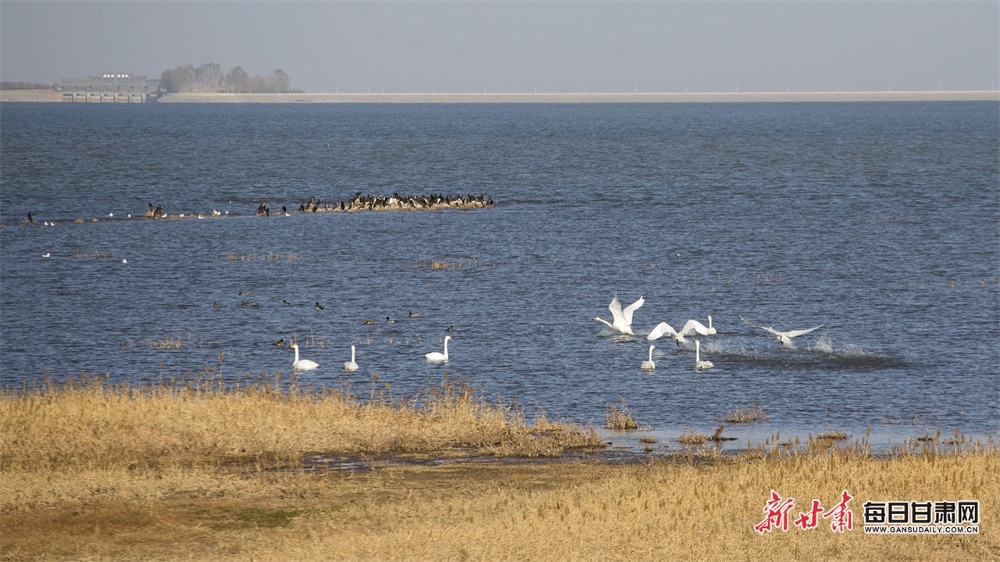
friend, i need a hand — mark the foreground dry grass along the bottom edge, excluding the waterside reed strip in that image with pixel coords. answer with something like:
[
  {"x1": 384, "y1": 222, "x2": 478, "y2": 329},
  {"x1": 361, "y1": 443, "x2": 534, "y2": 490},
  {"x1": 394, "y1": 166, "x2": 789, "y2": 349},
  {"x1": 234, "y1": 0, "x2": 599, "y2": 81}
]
[{"x1": 0, "y1": 426, "x2": 1000, "y2": 561}]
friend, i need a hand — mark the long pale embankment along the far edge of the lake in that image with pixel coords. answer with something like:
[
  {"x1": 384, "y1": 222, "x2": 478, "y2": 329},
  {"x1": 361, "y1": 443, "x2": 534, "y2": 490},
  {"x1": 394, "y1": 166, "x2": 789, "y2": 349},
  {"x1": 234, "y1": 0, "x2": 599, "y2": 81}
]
[{"x1": 0, "y1": 90, "x2": 1000, "y2": 104}]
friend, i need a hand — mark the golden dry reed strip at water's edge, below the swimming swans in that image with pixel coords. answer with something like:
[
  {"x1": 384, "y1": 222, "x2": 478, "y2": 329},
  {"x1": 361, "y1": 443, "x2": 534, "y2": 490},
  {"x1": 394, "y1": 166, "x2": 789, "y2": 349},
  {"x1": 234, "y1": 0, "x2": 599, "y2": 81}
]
[{"x1": 0, "y1": 371, "x2": 603, "y2": 476}]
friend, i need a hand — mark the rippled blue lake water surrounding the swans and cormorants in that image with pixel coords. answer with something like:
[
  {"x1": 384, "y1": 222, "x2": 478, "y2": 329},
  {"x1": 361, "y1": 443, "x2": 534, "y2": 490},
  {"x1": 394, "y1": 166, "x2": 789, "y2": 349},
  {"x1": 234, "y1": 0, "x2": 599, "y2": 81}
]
[{"x1": 0, "y1": 102, "x2": 1000, "y2": 445}]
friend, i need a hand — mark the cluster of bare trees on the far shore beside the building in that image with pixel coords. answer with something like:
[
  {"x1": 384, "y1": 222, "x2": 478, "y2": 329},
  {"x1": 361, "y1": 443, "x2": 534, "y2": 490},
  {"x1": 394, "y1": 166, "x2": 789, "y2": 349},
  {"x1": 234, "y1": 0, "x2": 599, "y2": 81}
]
[{"x1": 160, "y1": 62, "x2": 292, "y2": 94}]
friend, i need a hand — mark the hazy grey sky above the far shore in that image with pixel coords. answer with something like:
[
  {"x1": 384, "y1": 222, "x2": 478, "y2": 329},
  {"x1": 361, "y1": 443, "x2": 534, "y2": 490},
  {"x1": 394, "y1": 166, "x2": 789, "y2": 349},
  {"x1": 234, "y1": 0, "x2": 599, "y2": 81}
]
[{"x1": 0, "y1": 0, "x2": 1000, "y2": 93}]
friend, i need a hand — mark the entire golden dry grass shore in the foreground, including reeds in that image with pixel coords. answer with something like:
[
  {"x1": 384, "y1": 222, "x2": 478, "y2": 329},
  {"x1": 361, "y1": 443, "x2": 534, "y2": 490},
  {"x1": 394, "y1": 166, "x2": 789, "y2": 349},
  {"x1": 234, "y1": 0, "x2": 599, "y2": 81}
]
[{"x1": 0, "y1": 376, "x2": 1000, "y2": 560}]
